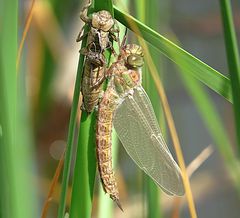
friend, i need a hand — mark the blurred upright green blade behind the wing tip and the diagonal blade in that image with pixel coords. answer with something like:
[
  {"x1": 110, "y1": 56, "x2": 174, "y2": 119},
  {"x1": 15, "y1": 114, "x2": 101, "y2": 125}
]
[{"x1": 136, "y1": 0, "x2": 164, "y2": 218}]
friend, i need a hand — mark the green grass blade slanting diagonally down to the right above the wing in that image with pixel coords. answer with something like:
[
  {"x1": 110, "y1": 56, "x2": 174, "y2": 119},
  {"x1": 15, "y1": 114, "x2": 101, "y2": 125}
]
[{"x1": 114, "y1": 6, "x2": 232, "y2": 102}]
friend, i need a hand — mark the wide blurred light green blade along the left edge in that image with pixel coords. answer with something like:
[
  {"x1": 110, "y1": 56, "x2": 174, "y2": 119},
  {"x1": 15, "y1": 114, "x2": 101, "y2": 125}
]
[{"x1": 0, "y1": 0, "x2": 38, "y2": 218}]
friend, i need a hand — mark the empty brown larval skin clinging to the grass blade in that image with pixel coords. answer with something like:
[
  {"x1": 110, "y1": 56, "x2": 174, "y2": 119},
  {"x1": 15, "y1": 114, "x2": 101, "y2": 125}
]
[{"x1": 76, "y1": 0, "x2": 119, "y2": 113}]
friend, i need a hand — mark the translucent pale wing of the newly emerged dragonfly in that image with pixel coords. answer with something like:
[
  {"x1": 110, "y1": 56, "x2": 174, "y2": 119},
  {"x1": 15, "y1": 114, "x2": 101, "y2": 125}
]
[{"x1": 113, "y1": 87, "x2": 184, "y2": 196}]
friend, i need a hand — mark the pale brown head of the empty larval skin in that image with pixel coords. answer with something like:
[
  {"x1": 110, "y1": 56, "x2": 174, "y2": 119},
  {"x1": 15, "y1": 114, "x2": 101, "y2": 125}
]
[{"x1": 92, "y1": 10, "x2": 114, "y2": 32}]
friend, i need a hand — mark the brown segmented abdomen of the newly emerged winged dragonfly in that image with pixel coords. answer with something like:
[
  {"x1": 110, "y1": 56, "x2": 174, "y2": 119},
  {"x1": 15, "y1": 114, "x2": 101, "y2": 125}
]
[{"x1": 96, "y1": 88, "x2": 122, "y2": 209}]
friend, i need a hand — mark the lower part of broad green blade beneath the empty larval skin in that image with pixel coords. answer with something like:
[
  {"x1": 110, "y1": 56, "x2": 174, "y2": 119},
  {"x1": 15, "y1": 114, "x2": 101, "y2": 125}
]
[{"x1": 69, "y1": 111, "x2": 96, "y2": 218}]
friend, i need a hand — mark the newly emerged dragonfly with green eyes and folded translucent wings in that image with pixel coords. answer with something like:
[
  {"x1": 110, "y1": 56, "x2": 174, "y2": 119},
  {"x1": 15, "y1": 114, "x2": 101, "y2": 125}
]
[{"x1": 96, "y1": 44, "x2": 185, "y2": 209}]
